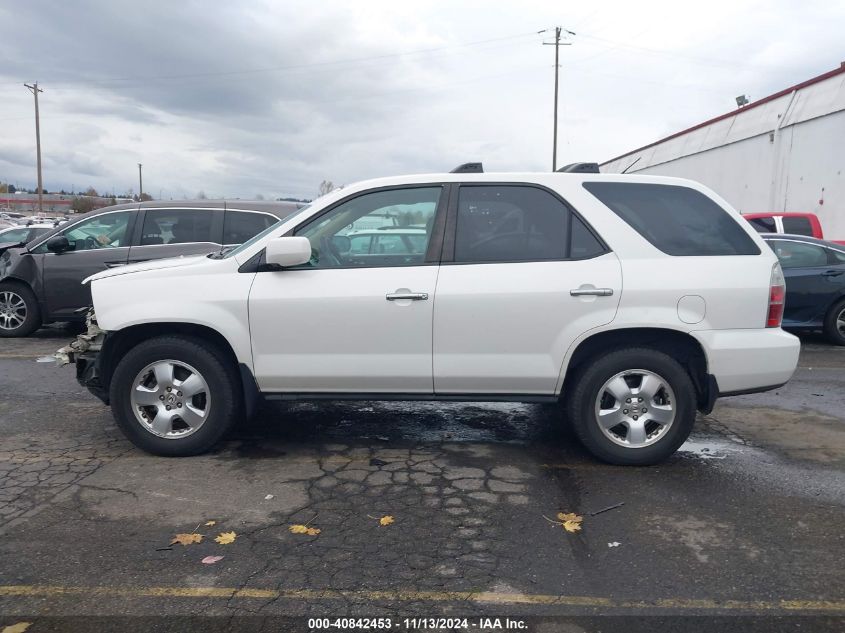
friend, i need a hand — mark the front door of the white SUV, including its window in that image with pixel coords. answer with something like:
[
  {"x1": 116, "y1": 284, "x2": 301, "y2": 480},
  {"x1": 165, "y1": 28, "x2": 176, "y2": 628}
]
[{"x1": 249, "y1": 185, "x2": 443, "y2": 394}]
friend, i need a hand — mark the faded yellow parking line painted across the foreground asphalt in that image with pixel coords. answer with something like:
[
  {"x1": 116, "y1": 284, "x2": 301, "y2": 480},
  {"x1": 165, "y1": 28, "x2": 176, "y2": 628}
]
[{"x1": 0, "y1": 585, "x2": 845, "y2": 613}]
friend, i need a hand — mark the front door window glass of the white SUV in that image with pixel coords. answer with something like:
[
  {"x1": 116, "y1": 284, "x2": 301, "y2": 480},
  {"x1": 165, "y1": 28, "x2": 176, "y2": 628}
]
[{"x1": 296, "y1": 186, "x2": 442, "y2": 268}]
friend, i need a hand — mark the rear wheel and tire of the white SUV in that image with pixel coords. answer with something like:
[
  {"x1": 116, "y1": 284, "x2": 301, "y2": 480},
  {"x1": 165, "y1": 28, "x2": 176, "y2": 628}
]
[{"x1": 564, "y1": 348, "x2": 696, "y2": 466}]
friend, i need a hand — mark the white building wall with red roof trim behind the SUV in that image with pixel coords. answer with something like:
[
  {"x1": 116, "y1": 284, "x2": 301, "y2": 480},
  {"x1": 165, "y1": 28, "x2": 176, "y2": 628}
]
[{"x1": 601, "y1": 67, "x2": 845, "y2": 240}]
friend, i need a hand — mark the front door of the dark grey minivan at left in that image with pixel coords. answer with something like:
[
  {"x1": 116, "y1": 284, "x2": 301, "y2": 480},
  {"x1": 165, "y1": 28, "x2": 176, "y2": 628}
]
[{"x1": 36, "y1": 209, "x2": 137, "y2": 319}]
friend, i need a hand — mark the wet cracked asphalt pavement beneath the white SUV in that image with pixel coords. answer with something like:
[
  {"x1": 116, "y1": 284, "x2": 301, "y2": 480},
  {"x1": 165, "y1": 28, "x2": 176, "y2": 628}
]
[{"x1": 0, "y1": 328, "x2": 845, "y2": 630}]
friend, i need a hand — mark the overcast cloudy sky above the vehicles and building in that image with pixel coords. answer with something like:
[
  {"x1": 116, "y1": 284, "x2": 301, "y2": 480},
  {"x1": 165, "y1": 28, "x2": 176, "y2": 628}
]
[{"x1": 0, "y1": 0, "x2": 845, "y2": 198}]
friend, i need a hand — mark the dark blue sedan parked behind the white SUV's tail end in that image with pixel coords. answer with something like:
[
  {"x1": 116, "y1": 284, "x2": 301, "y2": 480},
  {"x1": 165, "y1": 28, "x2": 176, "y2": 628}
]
[{"x1": 762, "y1": 235, "x2": 845, "y2": 345}]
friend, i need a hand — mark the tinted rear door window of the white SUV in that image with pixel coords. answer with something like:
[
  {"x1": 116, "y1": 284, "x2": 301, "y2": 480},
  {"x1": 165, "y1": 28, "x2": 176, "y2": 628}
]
[{"x1": 455, "y1": 186, "x2": 594, "y2": 262}]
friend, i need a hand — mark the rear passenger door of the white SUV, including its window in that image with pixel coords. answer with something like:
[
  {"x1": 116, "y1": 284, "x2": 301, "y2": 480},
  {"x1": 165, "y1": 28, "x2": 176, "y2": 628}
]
[{"x1": 433, "y1": 184, "x2": 622, "y2": 395}]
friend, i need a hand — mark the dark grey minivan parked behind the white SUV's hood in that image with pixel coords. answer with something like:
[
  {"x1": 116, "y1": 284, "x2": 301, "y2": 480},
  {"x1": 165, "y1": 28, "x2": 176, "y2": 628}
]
[{"x1": 0, "y1": 200, "x2": 302, "y2": 337}]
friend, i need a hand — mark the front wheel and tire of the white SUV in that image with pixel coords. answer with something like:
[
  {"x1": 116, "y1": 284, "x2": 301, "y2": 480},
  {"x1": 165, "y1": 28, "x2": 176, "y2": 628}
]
[{"x1": 109, "y1": 336, "x2": 242, "y2": 457}]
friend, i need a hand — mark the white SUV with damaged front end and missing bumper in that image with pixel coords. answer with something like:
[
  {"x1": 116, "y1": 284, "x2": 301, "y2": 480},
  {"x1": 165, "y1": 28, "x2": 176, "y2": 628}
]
[{"x1": 57, "y1": 173, "x2": 799, "y2": 464}]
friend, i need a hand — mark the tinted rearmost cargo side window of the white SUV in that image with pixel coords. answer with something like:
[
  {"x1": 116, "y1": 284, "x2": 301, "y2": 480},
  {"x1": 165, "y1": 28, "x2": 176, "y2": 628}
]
[{"x1": 584, "y1": 182, "x2": 760, "y2": 256}]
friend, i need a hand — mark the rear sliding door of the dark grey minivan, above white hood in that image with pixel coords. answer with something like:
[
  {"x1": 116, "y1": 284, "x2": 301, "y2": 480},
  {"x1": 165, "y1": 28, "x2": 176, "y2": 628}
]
[{"x1": 129, "y1": 207, "x2": 223, "y2": 263}]
